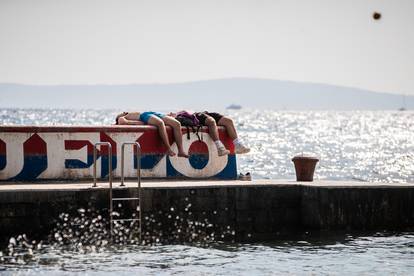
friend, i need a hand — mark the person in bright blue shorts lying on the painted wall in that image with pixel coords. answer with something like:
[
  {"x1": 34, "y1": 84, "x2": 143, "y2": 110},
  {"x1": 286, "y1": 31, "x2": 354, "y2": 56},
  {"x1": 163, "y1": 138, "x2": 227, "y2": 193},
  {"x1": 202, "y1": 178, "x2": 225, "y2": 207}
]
[{"x1": 115, "y1": 111, "x2": 188, "y2": 158}]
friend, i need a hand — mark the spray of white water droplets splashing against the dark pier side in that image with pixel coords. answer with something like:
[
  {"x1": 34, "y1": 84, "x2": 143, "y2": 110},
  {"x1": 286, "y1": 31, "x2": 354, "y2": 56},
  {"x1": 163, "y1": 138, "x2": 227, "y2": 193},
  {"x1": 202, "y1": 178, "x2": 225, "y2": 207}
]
[{"x1": 0, "y1": 201, "x2": 236, "y2": 267}]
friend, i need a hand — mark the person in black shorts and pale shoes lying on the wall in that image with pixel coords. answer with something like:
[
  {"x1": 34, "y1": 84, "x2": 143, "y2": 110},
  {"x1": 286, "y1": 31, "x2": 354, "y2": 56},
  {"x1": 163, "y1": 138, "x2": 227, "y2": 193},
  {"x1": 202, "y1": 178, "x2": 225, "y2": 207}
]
[{"x1": 168, "y1": 111, "x2": 250, "y2": 156}]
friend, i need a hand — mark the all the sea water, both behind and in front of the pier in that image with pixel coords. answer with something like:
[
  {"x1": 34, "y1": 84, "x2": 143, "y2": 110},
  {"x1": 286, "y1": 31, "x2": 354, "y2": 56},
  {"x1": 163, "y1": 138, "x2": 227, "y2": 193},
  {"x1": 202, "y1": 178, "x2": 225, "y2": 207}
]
[{"x1": 0, "y1": 109, "x2": 414, "y2": 275}]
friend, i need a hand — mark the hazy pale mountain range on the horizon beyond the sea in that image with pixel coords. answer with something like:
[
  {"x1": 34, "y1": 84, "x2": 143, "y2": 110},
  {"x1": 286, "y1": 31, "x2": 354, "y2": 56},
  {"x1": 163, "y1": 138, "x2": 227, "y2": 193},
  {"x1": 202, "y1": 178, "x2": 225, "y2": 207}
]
[{"x1": 0, "y1": 78, "x2": 414, "y2": 110}]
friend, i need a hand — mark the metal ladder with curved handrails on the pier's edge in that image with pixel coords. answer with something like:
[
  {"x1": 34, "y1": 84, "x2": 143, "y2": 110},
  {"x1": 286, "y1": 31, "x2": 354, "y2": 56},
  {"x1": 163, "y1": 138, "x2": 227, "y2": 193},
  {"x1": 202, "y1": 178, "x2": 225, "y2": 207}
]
[{"x1": 92, "y1": 142, "x2": 142, "y2": 241}]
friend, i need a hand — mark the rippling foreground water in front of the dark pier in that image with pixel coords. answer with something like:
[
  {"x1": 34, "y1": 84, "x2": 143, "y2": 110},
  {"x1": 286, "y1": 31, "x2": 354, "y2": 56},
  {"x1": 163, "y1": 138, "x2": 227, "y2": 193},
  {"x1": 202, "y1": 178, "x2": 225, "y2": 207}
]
[{"x1": 0, "y1": 219, "x2": 414, "y2": 275}]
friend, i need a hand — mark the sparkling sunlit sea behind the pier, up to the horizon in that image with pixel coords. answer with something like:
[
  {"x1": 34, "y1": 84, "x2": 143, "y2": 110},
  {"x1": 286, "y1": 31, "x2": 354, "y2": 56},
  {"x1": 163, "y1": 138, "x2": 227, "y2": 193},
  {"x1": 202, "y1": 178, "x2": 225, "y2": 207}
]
[{"x1": 0, "y1": 109, "x2": 414, "y2": 183}]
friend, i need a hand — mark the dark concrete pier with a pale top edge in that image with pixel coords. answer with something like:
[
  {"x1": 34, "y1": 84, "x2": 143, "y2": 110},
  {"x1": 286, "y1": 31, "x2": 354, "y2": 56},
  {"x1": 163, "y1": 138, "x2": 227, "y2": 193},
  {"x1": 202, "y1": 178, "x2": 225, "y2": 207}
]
[{"x1": 0, "y1": 180, "x2": 414, "y2": 243}]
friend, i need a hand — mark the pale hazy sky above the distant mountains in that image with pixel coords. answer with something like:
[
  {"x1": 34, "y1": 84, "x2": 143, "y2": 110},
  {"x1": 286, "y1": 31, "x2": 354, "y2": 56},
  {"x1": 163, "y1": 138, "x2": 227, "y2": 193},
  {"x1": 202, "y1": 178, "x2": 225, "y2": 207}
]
[{"x1": 0, "y1": 0, "x2": 414, "y2": 94}]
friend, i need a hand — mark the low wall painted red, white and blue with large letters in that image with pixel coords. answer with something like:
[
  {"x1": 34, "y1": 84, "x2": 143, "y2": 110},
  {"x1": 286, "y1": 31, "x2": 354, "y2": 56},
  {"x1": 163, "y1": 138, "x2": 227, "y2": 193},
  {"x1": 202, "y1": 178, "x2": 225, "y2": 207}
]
[{"x1": 0, "y1": 126, "x2": 237, "y2": 181}]
